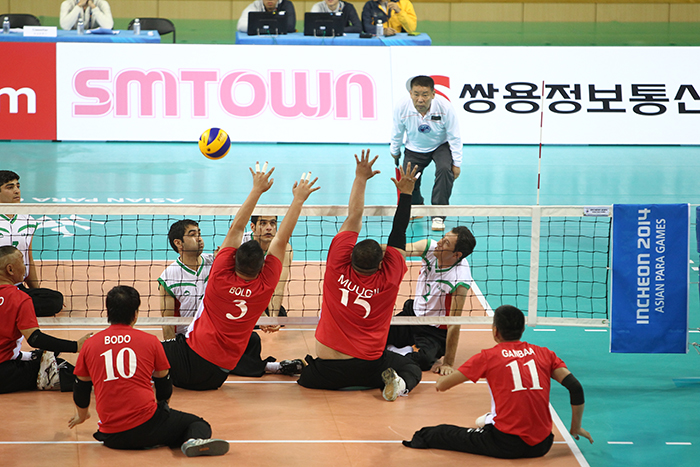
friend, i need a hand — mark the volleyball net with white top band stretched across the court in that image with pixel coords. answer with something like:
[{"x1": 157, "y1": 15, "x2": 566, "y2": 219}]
[{"x1": 12, "y1": 204, "x2": 611, "y2": 326}]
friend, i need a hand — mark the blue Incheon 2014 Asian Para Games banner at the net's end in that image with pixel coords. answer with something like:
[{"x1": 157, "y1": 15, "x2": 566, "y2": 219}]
[{"x1": 610, "y1": 204, "x2": 690, "y2": 353}]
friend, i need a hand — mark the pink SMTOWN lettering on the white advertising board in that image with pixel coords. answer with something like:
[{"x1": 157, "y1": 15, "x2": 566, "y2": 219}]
[{"x1": 73, "y1": 68, "x2": 377, "y2": 120}]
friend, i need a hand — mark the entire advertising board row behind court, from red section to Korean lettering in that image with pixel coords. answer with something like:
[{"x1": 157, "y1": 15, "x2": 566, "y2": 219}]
[{"x1": 0, "y1": 43, "x2": 700, "y2": 145}]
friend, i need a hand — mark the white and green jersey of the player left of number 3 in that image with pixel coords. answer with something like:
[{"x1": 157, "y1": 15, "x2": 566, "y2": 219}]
[{"x1": 158, "y1": 254, "x2": 214, "y2": 334}]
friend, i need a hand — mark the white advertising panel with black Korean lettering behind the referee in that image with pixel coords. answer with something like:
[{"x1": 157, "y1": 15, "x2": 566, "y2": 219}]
[{"x1": 391, "y1": 47, "x2": 700, "y2": 144}]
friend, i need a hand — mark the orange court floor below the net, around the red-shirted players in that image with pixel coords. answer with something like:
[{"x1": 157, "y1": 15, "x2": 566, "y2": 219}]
[{"x1": 0, "y1": 326, "x2": 588, "y2": 467}]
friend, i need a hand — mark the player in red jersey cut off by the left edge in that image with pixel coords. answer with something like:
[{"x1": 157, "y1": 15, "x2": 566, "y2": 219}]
[{"x1": 0, "y1": 245, "x2": 91, "y2": 394}]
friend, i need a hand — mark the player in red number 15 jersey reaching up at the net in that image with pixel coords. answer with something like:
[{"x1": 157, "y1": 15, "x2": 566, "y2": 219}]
[{"x1": 298, "y1": 150, "x2": 421, "y2": 401}]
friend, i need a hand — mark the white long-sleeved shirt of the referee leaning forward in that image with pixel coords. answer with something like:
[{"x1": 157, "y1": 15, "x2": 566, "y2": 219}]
[{"x1": 390, "y1": 95, "x2": 462, "y2": 167}]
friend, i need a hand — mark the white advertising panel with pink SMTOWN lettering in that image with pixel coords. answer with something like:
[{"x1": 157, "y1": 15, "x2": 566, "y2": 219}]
[{"x1": 57, "y1": 43, "x2": 392, "y2": 143}]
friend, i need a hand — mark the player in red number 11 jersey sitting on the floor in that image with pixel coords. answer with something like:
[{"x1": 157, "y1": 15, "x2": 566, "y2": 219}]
[{"x1": 403, "y1": 305, "x2": 593, "y2": 459}]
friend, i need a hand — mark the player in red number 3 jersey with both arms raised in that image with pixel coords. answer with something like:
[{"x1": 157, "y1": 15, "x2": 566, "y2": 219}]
[{"x1": 163, "y1": 163, "x2": 319, "y2": 390}]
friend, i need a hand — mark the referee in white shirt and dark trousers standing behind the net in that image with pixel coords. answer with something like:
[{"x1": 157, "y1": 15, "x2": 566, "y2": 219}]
[{"x1": 390, "y1": 76, "x2": 462, "y2": 231}]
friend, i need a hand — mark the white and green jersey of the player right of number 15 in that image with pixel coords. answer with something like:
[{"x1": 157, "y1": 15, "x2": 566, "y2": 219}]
[{"x1": 413, "y1": 239, "x2": 474, "y2": 324}]
